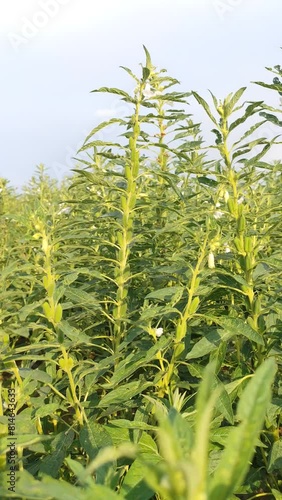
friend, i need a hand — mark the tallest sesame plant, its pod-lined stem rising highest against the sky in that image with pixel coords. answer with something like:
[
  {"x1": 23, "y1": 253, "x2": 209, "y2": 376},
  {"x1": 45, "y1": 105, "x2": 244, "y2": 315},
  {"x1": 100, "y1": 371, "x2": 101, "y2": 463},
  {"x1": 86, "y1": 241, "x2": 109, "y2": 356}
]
[{"x1": 77, "y1": 47, "x2": 190, "y2": 352}]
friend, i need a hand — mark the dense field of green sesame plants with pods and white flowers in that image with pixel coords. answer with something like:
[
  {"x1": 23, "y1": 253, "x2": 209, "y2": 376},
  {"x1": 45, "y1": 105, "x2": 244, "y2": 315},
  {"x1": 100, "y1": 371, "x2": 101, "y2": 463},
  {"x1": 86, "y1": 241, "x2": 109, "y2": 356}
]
[{"x1": 0, "y1": 48, "x2": 282, "y2": 500}]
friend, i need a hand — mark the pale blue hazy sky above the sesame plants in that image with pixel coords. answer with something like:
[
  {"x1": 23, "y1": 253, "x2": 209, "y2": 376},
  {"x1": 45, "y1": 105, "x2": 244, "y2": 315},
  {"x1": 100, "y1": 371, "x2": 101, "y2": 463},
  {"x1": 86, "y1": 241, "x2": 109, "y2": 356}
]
[{"x1": 0, "y1": 0, "x2": 282, "y2": 187}]
